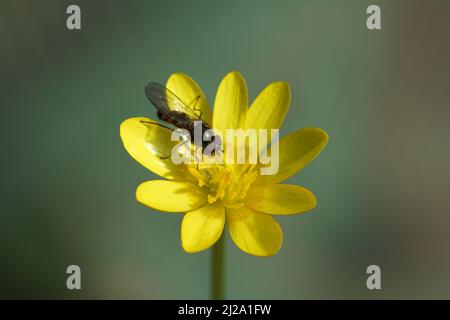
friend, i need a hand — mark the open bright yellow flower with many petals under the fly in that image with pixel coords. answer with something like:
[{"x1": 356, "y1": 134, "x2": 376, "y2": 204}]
[{"x1": 120, "y1": 72, "x2": 328, "y2": 256}]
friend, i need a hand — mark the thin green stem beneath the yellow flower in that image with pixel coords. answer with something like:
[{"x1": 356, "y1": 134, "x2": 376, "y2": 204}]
[{"x1": 211, "y1": 233, "x2": 225, "y2": 300}]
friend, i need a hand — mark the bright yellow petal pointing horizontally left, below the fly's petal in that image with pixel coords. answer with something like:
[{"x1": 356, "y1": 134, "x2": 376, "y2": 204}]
[{"x1": 136, "y1": 180, "x2": 206, "y2": 212}]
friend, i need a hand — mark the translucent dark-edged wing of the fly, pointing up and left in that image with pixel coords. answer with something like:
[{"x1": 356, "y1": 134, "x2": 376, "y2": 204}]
[{"x1": 145, "y1": 82, "x2": 201, "y2": 120}]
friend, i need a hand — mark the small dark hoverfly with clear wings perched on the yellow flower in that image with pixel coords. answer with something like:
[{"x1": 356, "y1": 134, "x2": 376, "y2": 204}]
[{"x1": 145, "y1": 82, "x2": 221, "y2": 159}]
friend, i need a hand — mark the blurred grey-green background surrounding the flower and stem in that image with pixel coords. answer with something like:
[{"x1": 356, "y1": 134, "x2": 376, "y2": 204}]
[{"x1": 0, "y1": 0, "x2": 450, "y2": 299}]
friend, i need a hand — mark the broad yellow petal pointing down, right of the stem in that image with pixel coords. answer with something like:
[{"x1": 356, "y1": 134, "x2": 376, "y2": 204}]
[{"x1": 227, "y1": 207, "x2": 283, "y2": 257}]
